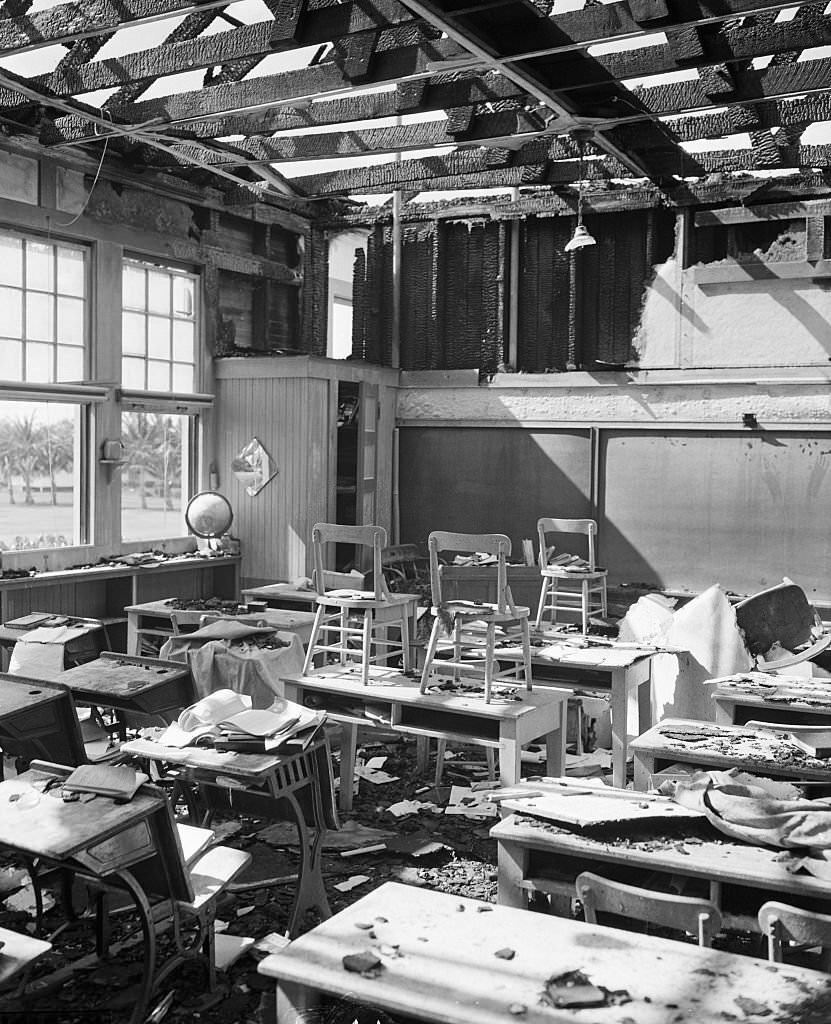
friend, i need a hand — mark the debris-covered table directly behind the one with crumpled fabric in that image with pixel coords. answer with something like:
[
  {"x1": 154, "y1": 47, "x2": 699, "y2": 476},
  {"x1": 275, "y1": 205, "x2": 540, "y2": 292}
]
[{"x1": 630, "y1": 719, "x2": 831, "y2": 790}]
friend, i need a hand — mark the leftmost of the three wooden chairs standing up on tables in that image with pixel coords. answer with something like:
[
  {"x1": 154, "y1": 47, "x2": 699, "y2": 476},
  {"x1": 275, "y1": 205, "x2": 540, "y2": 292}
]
[{"x1": 303, "y1": 522, "x2": 416, "y2": 686}]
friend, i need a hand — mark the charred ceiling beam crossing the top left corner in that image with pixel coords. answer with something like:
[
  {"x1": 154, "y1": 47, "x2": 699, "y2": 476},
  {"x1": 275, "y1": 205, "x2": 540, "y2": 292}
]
[{"x1": 0, "y1": 0, "x2": 235, "y2": 56}]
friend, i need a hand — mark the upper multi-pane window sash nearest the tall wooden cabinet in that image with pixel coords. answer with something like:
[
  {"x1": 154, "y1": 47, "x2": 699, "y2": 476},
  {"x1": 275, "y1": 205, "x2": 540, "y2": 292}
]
[{"x1": 121, "y1": 259, "x2": 198, "y2": 394}]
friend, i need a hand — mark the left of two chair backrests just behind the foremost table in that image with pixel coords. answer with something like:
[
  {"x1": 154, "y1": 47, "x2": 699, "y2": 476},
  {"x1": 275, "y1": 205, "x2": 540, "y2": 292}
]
[{"x1": 575, "y1": 871, "x2": 721, "y2": 946}]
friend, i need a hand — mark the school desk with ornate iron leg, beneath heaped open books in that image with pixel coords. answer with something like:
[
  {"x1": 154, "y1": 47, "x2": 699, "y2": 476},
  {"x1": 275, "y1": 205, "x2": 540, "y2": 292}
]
[{"x1": 122, "y1": 738, "x2": 340, "y2": 935}]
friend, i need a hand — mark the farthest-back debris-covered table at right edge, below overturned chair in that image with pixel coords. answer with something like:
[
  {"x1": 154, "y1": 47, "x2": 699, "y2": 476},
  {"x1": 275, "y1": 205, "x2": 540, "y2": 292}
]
[{"x1": 708, "y1": 672, "x2": 831, "y2": 725}]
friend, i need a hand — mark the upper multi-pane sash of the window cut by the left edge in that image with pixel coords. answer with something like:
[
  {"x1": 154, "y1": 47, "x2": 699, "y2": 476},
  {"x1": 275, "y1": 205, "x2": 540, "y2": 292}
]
[{"x1": 0, "y1": 232, "x2": 87, "y2": 384}]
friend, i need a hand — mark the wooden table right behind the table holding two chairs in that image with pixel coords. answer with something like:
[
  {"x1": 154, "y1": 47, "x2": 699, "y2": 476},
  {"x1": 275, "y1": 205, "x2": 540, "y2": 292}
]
[{"x1": 487, "y1": 630, "x2": 656, "y2": 786}]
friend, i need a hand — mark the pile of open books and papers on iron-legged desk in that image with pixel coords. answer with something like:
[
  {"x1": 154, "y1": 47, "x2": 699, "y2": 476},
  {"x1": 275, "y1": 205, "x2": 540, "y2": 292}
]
[{"x1": 159, "y1": 690, "x2": 325, "y2": 752}]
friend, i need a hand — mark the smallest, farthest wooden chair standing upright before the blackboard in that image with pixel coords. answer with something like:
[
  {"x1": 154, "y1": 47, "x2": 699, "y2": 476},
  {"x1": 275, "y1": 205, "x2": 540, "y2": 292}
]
[{"x1": 536, "y1": 518, "x2": 607, "y2": 633}]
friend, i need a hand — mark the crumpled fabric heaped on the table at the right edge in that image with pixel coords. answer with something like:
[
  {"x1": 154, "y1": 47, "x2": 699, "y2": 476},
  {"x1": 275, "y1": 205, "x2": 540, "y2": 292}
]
[{"x1": 671, "y1": 768, "x2": 831, "y2": 856}]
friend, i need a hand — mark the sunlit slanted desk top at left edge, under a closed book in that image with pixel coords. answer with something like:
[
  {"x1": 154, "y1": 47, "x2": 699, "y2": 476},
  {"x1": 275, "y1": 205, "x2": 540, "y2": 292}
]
[{"x1": 0, "y1": 769, "x2": 166, "y2": 860}]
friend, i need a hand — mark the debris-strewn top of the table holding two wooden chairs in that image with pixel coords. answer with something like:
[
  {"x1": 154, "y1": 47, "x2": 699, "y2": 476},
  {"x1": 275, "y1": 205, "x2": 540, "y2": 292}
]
[{"x1": 283, "y1": 666, "x2": 570, "y2": 719}]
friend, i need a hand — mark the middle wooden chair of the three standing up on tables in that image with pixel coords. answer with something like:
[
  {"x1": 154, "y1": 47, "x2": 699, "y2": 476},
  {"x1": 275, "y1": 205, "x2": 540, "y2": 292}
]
[{"x1": 421, "y1": 531, "x2": 531, "y2": 701}]
